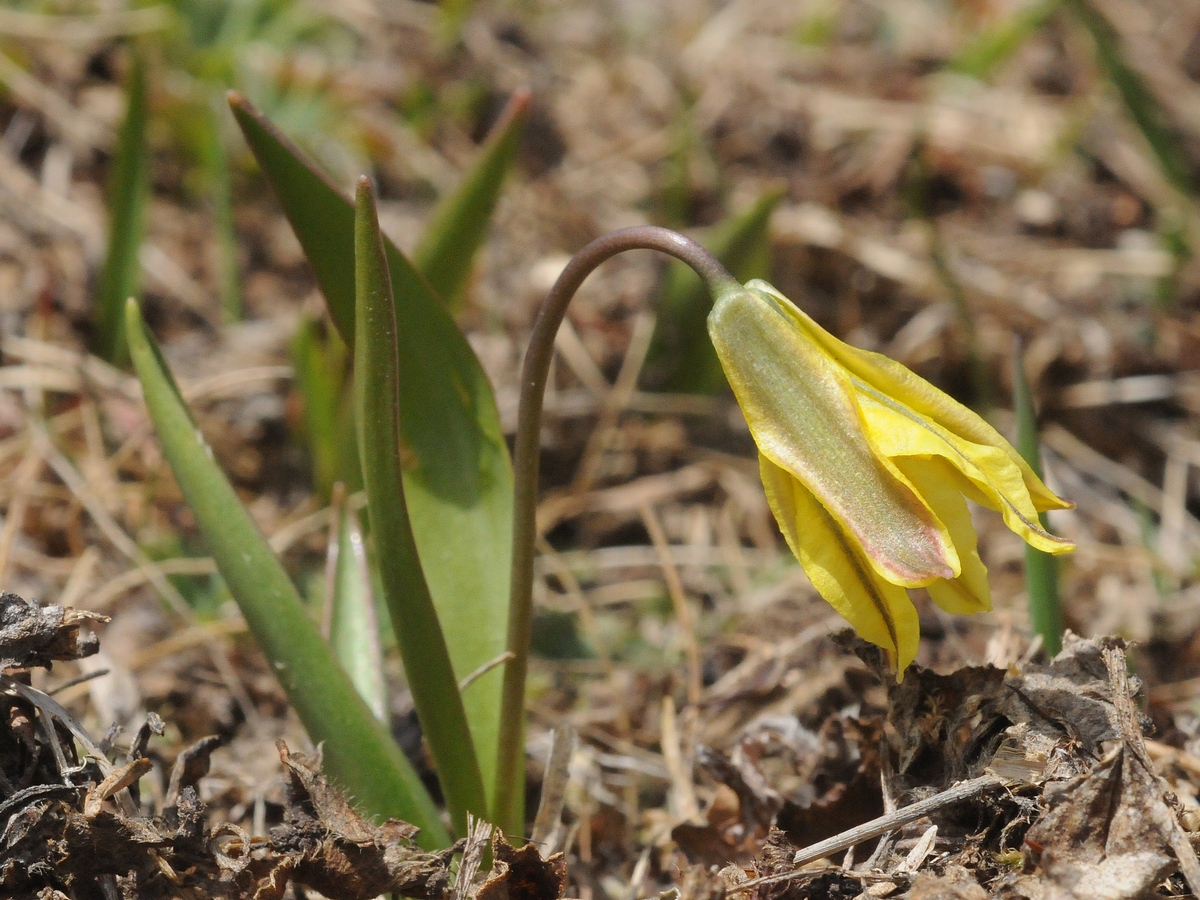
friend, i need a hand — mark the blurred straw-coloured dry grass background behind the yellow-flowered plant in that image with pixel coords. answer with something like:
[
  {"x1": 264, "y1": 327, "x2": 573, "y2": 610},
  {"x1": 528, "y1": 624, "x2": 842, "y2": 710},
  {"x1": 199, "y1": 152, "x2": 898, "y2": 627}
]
[{"x1": 0, "y1": 0, "x2": 1200, "y2": 895}]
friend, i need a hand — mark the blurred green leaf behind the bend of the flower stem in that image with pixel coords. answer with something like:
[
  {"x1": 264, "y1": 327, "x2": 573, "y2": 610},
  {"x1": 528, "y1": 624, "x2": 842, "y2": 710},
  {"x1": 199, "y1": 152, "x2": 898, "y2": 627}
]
[{"x1": 647, "y1": 188, "x2": 784, "y2": 394}]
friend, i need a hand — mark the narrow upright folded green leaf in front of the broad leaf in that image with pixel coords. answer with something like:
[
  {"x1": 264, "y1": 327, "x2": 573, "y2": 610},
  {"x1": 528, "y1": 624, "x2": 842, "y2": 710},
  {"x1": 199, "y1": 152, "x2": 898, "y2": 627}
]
[{"x1": 354, "y1": 179, "x2": 487, "y2": 834}]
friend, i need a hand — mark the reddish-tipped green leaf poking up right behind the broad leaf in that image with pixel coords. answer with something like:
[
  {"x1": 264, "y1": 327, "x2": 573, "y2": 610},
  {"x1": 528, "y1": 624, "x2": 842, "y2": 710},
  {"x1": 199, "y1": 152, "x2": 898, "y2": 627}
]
[{"x1": 413, "y1": 90, "x2": 529, "y2": 313}]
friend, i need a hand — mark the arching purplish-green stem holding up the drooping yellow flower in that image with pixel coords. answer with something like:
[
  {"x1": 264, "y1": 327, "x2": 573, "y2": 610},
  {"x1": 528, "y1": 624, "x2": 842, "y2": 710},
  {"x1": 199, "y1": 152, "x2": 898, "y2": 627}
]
[{"x1": 492, "y1": 226, "x2": 738, "y2": 836}]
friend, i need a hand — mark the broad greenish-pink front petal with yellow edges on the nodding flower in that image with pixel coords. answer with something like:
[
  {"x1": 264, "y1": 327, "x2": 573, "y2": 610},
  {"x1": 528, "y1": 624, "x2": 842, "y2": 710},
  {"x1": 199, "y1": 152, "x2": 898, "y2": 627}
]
[{"x1": 708, "y1": 289, "x2": 959, "y2": 587}]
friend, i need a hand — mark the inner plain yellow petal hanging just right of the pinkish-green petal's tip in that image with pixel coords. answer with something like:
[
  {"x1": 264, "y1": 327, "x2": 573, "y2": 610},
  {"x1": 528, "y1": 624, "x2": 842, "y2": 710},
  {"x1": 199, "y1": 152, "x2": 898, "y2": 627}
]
[{"x1": 896, "y1": 457, "x2": 991, "y2": 616}]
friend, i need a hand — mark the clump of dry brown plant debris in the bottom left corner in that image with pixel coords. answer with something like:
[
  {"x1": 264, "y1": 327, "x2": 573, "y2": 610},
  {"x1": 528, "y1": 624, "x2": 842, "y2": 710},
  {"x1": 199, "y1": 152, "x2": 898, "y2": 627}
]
[{"x1": 0, "y1": 593, "x2": 465, "y2": 900}]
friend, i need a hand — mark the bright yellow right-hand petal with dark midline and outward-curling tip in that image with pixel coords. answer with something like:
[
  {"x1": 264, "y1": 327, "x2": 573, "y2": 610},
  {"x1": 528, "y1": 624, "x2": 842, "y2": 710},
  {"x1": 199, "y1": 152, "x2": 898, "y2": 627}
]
[{"x1": 858, "y1": 389, "x2": 1075, "y2": 553}]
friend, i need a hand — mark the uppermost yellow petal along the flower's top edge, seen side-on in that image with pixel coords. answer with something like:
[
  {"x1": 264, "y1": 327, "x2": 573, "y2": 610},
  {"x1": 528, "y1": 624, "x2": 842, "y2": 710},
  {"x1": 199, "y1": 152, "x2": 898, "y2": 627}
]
[{"x1": 746, "y1": 281, "x2": 1074, "y2": 512}]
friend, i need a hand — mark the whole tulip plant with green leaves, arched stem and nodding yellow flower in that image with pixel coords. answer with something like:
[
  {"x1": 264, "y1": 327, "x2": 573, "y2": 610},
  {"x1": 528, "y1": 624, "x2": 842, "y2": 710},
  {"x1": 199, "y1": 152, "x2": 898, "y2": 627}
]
[{"x1": 126, "y1": 90, "x2": 1072, "y2": 847}]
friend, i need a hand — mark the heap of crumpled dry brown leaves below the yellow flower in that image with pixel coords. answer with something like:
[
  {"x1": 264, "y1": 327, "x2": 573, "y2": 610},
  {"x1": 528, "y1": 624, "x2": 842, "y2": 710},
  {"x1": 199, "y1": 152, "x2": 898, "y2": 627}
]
[{"x1": 673, "y1": 636, "x2": 1200, "y2": 900}]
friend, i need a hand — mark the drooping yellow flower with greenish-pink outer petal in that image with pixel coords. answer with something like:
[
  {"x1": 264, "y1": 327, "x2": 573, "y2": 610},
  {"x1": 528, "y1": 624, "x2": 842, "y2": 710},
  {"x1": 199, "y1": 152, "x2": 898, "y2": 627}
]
[{"x1": 708, "y1": 281, "x2": 1074, "y2": 677}]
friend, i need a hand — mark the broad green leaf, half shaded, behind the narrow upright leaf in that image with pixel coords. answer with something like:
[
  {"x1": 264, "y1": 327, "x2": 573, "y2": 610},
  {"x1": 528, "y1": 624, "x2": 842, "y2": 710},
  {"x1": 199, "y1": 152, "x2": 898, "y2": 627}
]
[{"x1": 230, "y1": 95, "x2": 512, "y2": 791}]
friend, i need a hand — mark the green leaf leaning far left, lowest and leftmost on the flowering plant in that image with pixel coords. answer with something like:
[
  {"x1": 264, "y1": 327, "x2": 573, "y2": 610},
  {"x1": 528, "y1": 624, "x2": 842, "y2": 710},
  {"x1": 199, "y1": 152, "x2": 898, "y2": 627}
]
[{"x1": 125, "y1": 300, "x2": 450, "y2": 847}]
